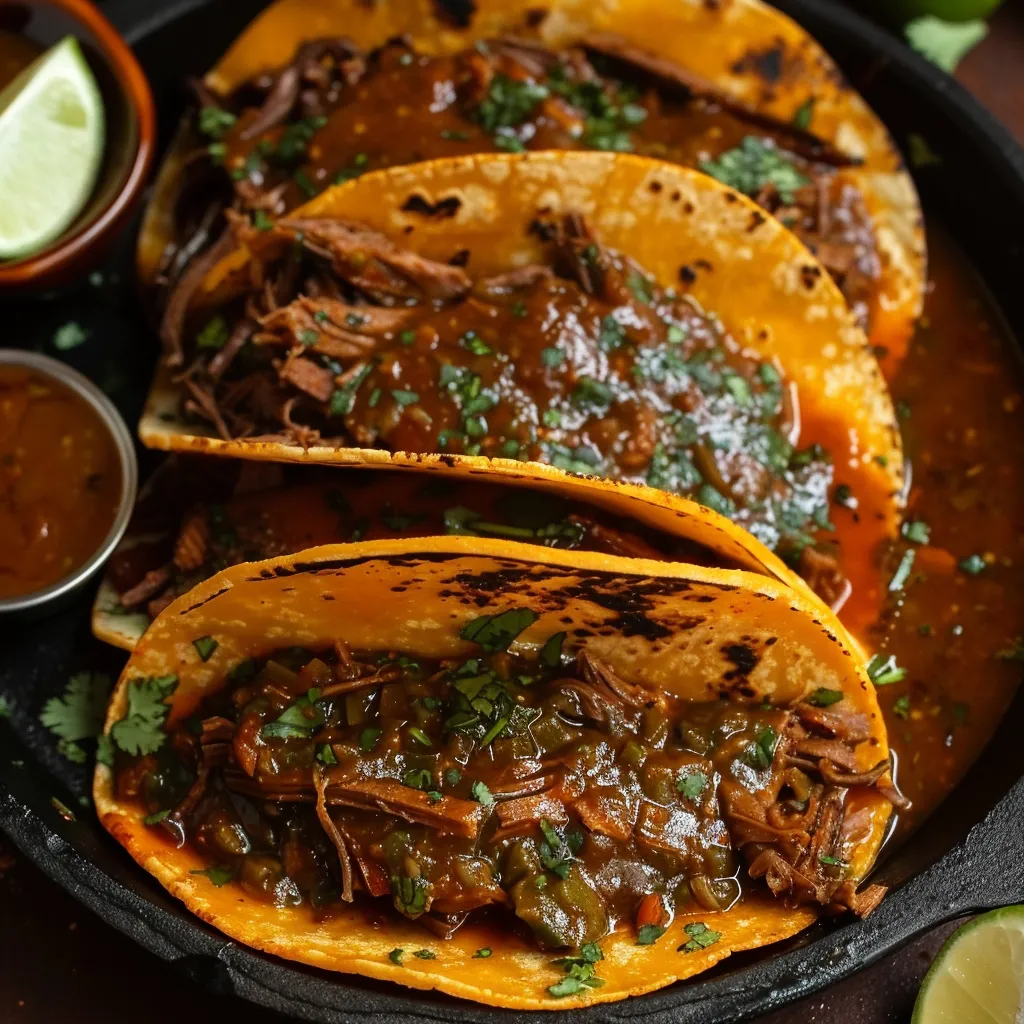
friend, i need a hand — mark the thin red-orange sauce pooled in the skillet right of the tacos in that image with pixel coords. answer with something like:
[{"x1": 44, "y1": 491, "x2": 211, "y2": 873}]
[{"x1": 864, "y1": 230, "x2": 1024, "y2": 829}]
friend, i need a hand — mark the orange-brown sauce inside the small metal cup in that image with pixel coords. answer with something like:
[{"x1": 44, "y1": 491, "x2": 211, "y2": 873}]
[{"x1": 0, "y1": 366, "x2": 122, "y2": 599}]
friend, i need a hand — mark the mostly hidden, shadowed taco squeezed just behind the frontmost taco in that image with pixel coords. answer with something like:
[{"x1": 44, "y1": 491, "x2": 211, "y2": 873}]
[{"x1": 92, "y1": 456, "x2": 815, "y2": 650}]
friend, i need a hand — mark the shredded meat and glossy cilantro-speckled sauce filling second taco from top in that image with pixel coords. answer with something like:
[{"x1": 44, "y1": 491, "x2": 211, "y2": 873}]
[{"x1": 165, "y1": 216, "x2": 833, "y2": 573}]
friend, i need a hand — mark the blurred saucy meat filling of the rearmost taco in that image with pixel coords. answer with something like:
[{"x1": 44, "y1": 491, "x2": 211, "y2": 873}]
[{"x1": 172, "y1": 34, "x2": 881, "y2": 327}]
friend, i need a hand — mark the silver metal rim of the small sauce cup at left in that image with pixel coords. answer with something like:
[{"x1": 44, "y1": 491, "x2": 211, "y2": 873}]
[{"x1": 0, "y1": 348, "x2": 138, "y2": 615}]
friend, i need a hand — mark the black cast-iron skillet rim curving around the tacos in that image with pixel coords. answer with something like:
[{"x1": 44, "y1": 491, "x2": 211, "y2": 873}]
[{"x1": 6, "y1": 0, "x2": 1024, "y2": 1024}]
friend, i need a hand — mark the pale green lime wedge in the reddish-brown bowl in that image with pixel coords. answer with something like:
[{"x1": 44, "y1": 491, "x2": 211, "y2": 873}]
[{"x1": 0, "y1": 36, "x2": 104, "y2": 259}]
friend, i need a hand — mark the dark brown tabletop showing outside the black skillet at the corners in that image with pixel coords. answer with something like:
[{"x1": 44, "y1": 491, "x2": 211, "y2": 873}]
[{"x1": 6, "y1": 0, "x2": 1024, "y2": 1024}]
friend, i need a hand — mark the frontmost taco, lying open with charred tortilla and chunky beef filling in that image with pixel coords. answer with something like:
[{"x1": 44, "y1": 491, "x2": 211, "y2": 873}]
[{"x1": 94, "y1": 538, "x2": 900, "y2": 1009}]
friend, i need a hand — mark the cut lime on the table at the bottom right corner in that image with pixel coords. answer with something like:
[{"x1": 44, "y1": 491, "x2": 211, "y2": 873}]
[{"x1": 911, "y1": 906, "x2": 1024, "y2": 1024}]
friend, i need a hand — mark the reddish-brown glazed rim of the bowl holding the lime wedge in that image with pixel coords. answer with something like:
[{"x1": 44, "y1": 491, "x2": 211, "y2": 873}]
[{"x1": 0, "y1": 0, "x2": 157, "y2": 288}]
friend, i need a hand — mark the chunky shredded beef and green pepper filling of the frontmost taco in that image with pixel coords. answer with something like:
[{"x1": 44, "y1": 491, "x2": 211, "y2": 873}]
[{"x1": 112, "y1": 638, "x2": 898, "y2": 949}]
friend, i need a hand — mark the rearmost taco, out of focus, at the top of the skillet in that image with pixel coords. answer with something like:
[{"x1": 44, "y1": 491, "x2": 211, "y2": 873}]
[{"x1": 140, "y1": 0, "x2": 925, "y2": 368}]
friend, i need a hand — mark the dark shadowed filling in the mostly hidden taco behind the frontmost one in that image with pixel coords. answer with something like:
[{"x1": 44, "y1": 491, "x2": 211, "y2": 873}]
[{"x1": 102, "y1": 462, "x2": 745, "y2": 620}]
